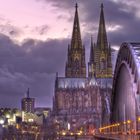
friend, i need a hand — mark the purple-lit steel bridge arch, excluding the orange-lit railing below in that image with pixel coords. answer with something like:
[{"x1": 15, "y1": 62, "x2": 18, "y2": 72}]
[{"x1": 111, "y1": 43, "x2": 140, "y2": 122}]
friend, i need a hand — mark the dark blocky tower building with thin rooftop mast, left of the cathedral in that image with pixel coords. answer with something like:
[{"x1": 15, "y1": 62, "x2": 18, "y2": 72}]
[{"x1": 21, "y1": 88, "x2": 35, "y2": 113}]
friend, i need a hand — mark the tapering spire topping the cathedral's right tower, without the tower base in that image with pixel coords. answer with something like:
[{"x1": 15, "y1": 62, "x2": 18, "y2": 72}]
[{"x1": 97, "y1": 3, "x2": 108, "y2": 50}]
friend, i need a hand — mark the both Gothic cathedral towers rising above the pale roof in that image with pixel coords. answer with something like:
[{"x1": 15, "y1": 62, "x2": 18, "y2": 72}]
[{"x1": 65, "y1": 4, "x2": 112, "y2": 78}]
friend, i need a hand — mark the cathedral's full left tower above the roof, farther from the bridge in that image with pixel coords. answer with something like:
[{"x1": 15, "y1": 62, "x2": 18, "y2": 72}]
[{"x1": 65, "y1": 4, "x2": 86, "y2": 78}]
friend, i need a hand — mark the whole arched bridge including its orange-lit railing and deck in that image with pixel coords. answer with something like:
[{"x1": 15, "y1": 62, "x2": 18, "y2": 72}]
[{"x1": 99, "y1": 42, "x2": 140, "y2": 140}]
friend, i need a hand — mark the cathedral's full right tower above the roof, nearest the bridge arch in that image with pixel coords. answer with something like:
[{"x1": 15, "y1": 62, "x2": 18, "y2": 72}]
[{"x1": 89, "y1": 4, "x2": 112, "y2": 78}]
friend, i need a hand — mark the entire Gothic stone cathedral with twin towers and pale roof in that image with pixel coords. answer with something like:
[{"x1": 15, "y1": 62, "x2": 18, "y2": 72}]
[{"x1": 53, "y1": 4, "x2": 112, "y2": 128}]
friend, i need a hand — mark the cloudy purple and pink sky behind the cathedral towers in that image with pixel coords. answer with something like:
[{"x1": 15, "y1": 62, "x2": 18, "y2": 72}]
[{"x1": 0, "y1": 0, "x2": 140, "y2": 108}]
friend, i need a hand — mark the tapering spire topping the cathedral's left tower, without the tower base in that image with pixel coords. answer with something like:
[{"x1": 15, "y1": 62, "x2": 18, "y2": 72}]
[{"x1": 71, "y1": 3, "x2": 82, "y2": 48}]
